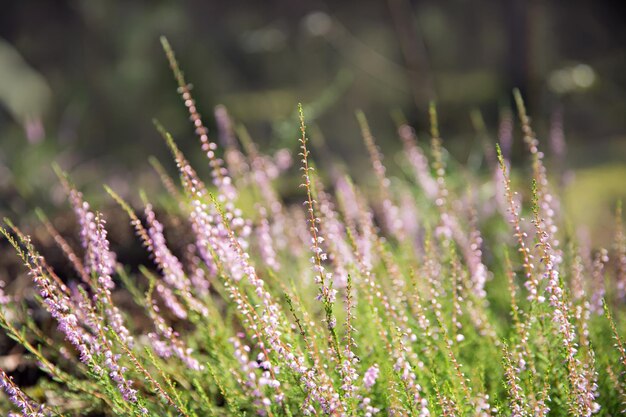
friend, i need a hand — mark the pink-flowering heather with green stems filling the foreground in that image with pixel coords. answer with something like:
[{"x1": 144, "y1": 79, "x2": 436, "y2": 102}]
[{"x1": 0, "y1": 39, "x2": 626, "y2": 417}]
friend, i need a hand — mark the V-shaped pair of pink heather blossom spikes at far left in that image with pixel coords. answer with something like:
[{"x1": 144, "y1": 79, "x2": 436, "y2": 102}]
[{"x1": 2, "y1": 197, "x2": 144, "y2": 412}]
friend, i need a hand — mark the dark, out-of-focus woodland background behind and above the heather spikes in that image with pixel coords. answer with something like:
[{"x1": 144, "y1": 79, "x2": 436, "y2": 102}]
[{"x1": 0, "y1": 0, "x2": 626, "y2": 239}]
